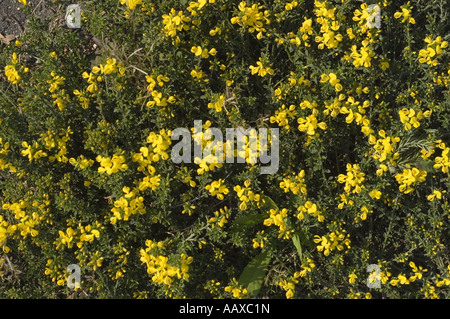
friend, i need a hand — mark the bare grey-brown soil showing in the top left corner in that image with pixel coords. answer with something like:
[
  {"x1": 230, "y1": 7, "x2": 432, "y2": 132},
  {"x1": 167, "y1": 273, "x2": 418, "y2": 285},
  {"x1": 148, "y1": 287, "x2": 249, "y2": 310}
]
[{"x1": 0, "y1": 0, "x2": 51, "y2": 43}]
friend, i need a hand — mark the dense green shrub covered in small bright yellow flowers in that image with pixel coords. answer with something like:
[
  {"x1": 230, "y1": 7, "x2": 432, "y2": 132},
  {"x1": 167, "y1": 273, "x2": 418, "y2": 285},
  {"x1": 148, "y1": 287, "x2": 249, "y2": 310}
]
[{"x1": 0, "y1": 0, "x2": 450, "y2": 298}]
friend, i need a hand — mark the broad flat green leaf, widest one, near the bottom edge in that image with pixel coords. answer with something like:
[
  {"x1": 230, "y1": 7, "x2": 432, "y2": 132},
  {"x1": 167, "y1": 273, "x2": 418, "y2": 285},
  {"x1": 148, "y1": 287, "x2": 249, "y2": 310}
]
[{"x1": 239, "y1": 251, "x2": 271, "y2": 297}]
